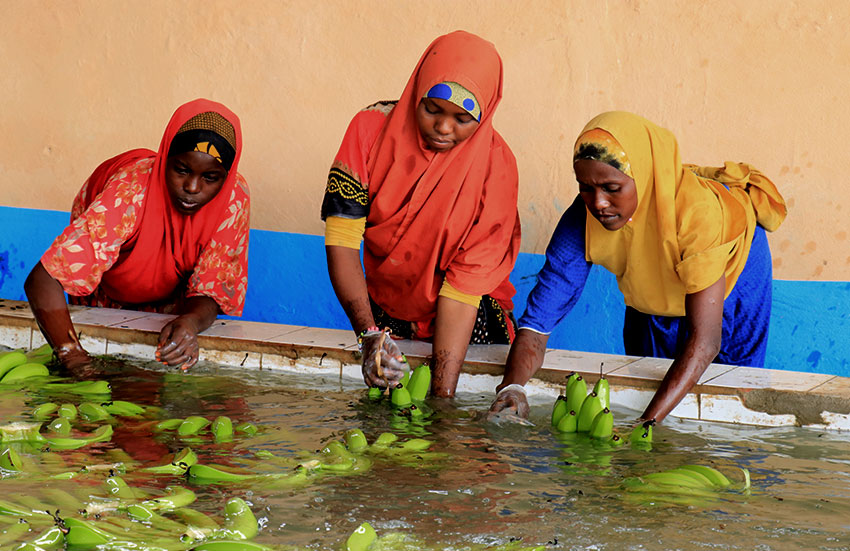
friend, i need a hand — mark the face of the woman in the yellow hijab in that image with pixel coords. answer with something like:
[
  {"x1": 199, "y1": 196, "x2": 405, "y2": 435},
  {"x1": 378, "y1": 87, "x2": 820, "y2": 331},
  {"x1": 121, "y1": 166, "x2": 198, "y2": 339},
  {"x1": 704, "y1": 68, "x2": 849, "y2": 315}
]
[{"x1": 573, "y1": 159, "x2": 638, "y2": 231}]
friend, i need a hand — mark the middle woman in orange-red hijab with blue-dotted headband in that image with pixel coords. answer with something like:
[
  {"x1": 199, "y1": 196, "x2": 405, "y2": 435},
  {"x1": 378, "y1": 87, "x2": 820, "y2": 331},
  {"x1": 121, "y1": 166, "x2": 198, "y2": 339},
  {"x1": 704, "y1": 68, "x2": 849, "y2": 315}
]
[{"x1": 322, "y1": 31, "x2": 520, "y2": 396}]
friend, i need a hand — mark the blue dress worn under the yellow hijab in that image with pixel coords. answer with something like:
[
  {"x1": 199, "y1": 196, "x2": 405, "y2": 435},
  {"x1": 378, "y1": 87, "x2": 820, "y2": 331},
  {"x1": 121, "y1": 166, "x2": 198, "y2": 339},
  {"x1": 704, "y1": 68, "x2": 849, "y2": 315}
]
[{"x1": 518, "y1": 197, "x2": 773, "y2": 367}]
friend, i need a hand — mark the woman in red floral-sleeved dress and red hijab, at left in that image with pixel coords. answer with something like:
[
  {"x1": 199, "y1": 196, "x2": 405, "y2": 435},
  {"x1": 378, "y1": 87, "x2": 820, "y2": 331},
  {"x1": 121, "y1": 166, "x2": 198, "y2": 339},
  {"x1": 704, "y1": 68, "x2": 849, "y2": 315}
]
[{"x1": 24, "y1": 99, "x2": 249, "y2": 373}]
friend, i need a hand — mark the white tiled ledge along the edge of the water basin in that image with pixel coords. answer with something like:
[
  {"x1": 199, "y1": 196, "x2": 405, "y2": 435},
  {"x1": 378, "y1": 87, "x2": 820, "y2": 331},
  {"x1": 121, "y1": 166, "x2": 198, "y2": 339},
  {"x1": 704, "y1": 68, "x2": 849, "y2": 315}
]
[{"x1": 0, "y1": 299, "x2": 850, "y2": 430}]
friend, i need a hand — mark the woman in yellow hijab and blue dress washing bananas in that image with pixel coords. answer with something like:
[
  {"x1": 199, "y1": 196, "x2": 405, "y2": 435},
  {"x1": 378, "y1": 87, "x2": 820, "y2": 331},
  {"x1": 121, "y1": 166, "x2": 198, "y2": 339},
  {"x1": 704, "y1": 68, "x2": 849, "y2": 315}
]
[{"x1": 491, "y1": 111, "x2": 786, "y2": 421}]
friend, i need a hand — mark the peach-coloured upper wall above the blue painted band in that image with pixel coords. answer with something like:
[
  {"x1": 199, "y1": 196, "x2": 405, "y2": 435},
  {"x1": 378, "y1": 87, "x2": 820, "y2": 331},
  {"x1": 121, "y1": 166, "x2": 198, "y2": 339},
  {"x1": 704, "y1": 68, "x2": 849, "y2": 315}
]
[{"x1": 0, "y1": 0, "x2": 850, "y2": 280}]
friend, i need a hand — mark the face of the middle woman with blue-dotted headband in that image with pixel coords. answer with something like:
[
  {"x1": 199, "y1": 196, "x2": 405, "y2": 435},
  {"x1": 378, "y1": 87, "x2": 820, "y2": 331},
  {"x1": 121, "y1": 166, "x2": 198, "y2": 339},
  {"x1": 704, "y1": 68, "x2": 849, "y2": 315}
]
[{"x1": 416, "y1": 98, "x2": 478, "y2": 152}]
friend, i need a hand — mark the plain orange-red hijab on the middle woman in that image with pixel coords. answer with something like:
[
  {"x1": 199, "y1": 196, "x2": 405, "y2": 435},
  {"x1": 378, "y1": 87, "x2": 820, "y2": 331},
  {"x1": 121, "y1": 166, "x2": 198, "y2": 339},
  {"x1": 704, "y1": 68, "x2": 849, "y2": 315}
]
[{"x1": 364, "y1": 31, "x2": 520, "y2": 333}]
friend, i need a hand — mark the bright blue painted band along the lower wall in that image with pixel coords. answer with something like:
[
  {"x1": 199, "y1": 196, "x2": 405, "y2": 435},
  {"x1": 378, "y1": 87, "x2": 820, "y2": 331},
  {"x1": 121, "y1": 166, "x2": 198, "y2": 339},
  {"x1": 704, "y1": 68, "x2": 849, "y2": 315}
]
[{"x1": 0, "y1": 207, "x2": 850, "y2": 376}]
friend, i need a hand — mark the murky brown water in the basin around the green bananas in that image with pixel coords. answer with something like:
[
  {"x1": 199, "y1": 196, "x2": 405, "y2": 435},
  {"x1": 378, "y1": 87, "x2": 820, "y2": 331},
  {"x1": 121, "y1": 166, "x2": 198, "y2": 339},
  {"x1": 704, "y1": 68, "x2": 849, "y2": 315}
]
[{"x1": 0, "y1": 360, "x2": 850, "y2": 551}]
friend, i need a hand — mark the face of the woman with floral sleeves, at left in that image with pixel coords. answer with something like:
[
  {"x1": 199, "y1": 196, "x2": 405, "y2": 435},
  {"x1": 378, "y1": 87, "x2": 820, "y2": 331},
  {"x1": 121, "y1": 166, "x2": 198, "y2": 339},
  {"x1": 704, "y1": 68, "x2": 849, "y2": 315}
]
[{"x1": 165, "y1": 151, "x2": 227, "y2": 214}]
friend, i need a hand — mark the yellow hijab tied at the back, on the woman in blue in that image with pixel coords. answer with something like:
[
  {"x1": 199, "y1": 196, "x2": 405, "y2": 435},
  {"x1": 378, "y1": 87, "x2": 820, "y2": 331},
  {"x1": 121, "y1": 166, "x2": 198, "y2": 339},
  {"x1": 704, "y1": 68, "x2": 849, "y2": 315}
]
[{"x1": 576, "y1": 111, "x2": 786, "y2": 316}]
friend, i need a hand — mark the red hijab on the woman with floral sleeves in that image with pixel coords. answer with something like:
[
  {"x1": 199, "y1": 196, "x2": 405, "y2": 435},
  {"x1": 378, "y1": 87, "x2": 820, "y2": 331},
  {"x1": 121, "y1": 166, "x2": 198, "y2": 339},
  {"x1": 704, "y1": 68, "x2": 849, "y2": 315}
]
[{"x1": 78, "y1": 99, "x2": 242, "y2": 304}]
